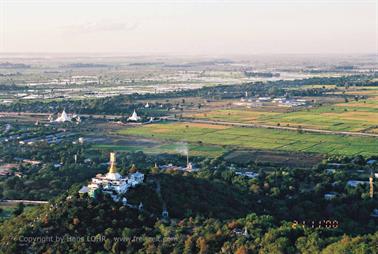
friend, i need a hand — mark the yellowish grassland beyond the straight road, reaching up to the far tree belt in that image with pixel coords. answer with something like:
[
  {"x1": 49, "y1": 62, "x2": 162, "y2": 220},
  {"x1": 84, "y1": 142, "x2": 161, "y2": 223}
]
[{"x1": 184, "y1": 86, "x2": 378, "y2": 132}]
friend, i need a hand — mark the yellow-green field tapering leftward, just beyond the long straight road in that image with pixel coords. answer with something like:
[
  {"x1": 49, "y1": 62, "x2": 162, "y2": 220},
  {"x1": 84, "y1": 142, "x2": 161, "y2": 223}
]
[{"x1": 186, "y1": 100, "x2": 378, "y2": 132}]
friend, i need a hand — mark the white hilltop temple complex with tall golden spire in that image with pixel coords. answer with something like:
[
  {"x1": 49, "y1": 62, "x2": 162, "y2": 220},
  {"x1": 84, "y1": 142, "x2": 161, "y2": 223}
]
[{"x1": 79, "y1": 153, "x2": 144, "y2": 204}]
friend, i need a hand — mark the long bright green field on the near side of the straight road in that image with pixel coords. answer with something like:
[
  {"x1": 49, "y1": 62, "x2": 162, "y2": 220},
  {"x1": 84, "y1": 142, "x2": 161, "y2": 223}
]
[{"x1": 118, "y1": 123, "x2": 378, "y2": 156}]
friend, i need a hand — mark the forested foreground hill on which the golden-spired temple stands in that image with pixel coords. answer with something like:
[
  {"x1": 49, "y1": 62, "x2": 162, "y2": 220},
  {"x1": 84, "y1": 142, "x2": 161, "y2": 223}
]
[{"x1": 0, "y1": 172, "x2": 378, "y2": 254}]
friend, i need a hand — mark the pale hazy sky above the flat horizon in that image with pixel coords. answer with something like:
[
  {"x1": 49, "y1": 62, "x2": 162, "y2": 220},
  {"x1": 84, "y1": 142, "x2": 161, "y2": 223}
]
[{"x1": 0, "y1": 0, "x2": 378, "y2": 55}]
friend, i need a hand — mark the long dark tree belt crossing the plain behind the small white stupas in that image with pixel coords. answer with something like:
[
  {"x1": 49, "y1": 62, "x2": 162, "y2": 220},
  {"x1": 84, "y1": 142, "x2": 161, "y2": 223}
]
[{"x1": 0, "y1": 76, "x2": 354, "y2": 116}]
